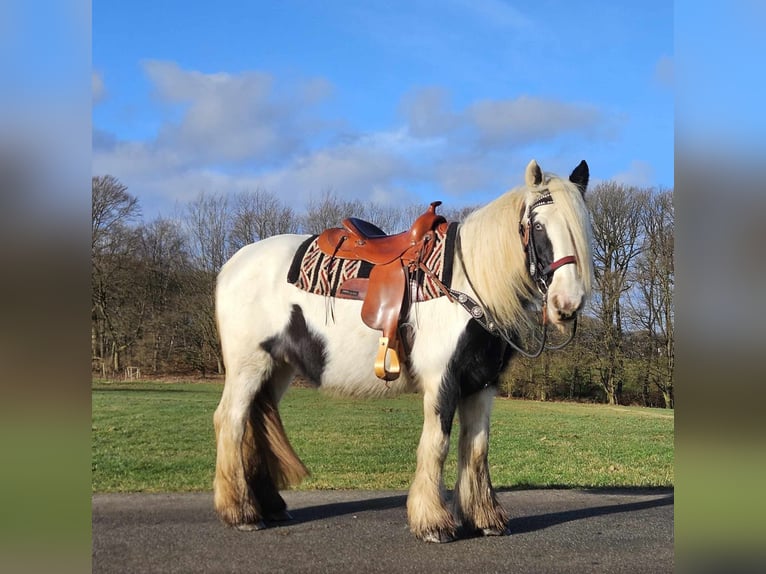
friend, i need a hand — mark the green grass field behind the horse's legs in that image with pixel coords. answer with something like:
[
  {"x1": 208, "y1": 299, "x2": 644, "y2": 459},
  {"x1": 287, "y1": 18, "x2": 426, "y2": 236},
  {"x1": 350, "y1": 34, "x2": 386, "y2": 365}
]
[{"x1": 92, "y1": 382, "x2": 674, "y2": 492}]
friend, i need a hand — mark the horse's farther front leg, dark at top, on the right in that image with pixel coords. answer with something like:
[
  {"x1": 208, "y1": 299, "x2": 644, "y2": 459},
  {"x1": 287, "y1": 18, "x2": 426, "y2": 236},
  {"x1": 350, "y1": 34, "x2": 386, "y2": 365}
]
[{"x1": 454, "y1": 387, "x2": 509, "y2": 536}]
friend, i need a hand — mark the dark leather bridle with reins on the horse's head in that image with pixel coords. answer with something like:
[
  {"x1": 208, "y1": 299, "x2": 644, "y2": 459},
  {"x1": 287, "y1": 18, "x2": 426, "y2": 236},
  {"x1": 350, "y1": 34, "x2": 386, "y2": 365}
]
[{"x1": 445, "y1": 191, "x2": 577, "y2": 359}]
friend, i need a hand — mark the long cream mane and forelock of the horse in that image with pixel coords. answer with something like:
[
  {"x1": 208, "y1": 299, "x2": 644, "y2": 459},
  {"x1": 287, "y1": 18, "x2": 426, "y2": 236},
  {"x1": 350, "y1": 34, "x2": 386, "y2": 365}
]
[{"x1": 460, "y1": 174, "x2": 593, "y2": 326}]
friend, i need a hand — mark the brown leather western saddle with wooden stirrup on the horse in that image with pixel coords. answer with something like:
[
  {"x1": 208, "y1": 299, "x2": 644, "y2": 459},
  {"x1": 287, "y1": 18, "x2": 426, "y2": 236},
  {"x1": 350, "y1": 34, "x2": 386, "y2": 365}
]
[{"x1": 317, "y1": 201, "x2": 447, "y2": 381}]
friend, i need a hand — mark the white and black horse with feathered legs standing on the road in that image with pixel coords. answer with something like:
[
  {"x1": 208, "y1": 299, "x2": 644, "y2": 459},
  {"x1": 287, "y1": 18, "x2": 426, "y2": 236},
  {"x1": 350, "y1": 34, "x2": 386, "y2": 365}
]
[{"x1": 213, "y1": 160, "x2": 593, "y2": 543}]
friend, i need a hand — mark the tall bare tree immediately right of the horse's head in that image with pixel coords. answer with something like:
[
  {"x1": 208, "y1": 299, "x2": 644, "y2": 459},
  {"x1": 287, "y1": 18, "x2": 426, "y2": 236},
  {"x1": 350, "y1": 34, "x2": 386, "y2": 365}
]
[{"x1": 588, "y1": 182, "x2": 647, "y2": 404}]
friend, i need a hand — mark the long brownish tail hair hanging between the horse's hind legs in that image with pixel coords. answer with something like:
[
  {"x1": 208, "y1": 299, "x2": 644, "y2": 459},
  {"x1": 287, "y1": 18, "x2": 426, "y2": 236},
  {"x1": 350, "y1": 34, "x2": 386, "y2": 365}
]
[{"x1": 242, "y1": 387, "x2": 309, "y2": 490}]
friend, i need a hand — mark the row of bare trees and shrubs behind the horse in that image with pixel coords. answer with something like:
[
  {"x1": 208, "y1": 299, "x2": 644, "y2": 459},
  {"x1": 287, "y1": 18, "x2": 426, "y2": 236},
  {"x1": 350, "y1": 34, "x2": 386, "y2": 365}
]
[{"x1": 91, "y1": 175, "x2": 674, "y2": 408}]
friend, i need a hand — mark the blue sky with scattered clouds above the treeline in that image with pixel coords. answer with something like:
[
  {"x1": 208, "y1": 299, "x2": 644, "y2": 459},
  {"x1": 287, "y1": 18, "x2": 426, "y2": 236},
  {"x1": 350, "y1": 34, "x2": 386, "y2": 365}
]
[{"x1": 92, "y1": 0, "x2": 674, "y2": 217}]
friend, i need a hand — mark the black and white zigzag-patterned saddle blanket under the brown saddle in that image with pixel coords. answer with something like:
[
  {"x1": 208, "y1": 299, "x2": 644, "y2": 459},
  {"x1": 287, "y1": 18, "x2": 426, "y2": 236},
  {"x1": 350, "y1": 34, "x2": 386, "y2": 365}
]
[{"x1": 287, "y1": 222, "x2": 458, "y2": 301}]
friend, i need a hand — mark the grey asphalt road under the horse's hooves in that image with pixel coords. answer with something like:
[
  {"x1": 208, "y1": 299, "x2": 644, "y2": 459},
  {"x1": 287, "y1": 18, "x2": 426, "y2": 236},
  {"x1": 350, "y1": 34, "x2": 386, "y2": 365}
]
[{"x1": 92, "y1": 490, "x2": 674, "y2": 574}]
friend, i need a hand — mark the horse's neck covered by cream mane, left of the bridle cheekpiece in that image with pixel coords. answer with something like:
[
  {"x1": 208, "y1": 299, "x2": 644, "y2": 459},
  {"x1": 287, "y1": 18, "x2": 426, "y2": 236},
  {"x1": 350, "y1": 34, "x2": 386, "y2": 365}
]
[{"x1": 460, "y1": 191, "x2": 534, "y2": 325}]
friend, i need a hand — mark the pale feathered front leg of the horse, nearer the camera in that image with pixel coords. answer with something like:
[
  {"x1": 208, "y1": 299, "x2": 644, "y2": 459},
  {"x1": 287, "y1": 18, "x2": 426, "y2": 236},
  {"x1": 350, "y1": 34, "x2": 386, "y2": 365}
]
[{"x1": 407, "y1": 391, "x2": 457, "y2": 542}]
